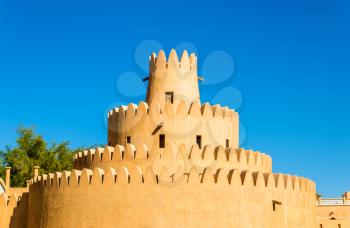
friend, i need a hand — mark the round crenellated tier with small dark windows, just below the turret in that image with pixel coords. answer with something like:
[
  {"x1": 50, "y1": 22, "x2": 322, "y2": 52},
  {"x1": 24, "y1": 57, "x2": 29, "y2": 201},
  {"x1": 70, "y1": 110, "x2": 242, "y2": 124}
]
[{"x1": 108, "y1": 101, "x2": 239, "y2": 149}]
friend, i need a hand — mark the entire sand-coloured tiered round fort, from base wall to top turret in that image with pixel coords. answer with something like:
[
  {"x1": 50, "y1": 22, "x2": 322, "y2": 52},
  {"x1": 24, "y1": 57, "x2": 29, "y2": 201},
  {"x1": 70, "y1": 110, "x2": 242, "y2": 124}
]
[{"x1": 0, "y1": 47, "x2": 318, "y2": 228}]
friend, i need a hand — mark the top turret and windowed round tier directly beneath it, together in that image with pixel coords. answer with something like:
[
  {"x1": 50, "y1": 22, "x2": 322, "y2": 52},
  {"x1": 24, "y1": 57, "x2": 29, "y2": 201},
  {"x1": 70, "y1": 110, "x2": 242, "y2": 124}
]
[{"x1": 108, "y1": 49, "x2": 239, "y2": 149}]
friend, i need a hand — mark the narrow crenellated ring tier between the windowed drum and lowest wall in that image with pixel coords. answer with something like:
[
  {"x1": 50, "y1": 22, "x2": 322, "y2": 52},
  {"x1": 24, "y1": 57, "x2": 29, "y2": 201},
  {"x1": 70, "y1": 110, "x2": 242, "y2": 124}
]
[{"x1": 73, "y1": 143, "x2": 272, "y2": 172}]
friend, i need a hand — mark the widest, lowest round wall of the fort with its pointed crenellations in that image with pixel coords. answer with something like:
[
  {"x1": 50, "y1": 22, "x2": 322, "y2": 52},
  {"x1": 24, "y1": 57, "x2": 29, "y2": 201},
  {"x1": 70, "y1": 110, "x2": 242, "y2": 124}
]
[{"x1": 28, "y1": 167, "x2": 316, "y2": 228}]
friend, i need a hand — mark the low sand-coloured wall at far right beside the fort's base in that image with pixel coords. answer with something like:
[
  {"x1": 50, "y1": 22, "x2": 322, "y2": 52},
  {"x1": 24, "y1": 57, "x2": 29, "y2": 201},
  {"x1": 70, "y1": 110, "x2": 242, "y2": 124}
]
[{"x1": 316, "y1": 205, "x2": 350, "y2": 228}]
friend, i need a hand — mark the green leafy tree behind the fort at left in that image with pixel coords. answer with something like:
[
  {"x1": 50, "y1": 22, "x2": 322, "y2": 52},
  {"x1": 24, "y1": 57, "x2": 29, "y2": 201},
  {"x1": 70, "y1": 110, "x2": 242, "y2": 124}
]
[{"x1": 0, "y1": 128, "x2": 83, "y2": 187}]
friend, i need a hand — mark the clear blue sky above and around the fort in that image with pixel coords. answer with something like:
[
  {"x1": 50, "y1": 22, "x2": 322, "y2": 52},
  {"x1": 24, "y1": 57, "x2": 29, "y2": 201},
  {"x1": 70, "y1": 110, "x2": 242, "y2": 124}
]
[{"x1": 0, "y1": 0, "x2": 350, "y2": 196}]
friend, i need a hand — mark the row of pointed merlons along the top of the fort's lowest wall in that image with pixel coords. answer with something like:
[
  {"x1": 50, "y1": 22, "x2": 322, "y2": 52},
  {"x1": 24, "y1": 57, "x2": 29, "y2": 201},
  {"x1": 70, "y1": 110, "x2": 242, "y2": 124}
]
[{"x1": 28, "y1": 166, "x2": 315, "y2": 194}]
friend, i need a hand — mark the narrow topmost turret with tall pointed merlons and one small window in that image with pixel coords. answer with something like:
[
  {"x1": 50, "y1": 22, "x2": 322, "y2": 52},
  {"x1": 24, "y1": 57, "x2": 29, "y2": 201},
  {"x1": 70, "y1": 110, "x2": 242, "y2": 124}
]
[{"x1": 146, "y1": 49, "x2": 200, "y2": 105}]
